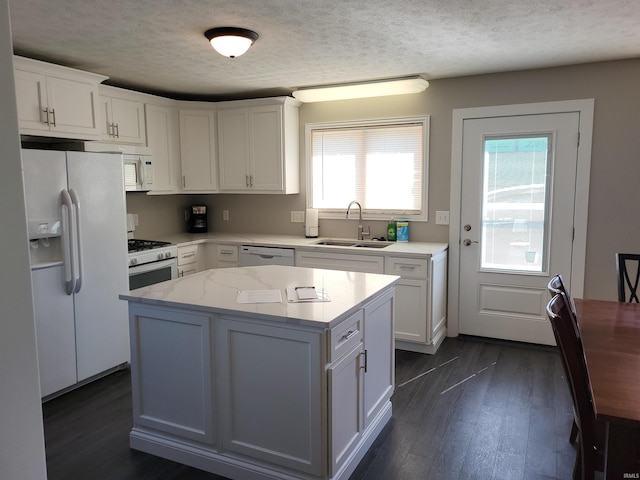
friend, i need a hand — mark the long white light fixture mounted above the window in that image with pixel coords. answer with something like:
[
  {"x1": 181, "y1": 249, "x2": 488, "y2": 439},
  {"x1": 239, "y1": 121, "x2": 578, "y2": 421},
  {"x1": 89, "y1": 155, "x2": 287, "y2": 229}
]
[{"x1": 292, "y1": 77, "x2": 429, "y2": 103}]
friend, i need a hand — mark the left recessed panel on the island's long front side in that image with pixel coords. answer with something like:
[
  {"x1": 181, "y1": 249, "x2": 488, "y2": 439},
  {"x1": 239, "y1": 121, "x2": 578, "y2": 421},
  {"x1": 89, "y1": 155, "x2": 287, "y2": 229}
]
[{"x1": 130, "y1": 305, "x2": 216, "y2": 445}]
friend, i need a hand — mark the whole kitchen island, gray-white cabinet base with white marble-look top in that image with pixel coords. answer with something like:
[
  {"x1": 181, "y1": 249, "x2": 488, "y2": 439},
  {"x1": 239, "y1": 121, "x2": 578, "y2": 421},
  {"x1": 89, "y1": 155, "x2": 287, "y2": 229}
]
[{"x1": 120, "y1": 266, "x2": 399, "y2": 480}]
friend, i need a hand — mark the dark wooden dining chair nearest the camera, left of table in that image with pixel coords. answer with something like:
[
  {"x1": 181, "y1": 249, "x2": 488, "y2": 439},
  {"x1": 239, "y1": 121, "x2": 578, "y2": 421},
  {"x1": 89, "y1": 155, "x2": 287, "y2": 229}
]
[{"x1": 547, "y1": 292, "x2": 604, "y2": 480}]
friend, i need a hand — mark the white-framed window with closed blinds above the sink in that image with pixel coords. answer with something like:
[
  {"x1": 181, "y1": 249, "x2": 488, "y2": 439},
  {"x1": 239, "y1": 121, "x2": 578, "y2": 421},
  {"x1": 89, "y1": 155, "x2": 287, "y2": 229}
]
[{"x1": 307, "y1": 117, "x2": 429, "y2": 219}]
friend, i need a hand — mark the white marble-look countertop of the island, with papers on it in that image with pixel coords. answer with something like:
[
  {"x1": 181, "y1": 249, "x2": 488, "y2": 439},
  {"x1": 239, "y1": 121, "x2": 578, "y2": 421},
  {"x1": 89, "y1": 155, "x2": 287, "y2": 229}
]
[{"x1": 120, "y1": 265, "x2": 400, "y2": 328}]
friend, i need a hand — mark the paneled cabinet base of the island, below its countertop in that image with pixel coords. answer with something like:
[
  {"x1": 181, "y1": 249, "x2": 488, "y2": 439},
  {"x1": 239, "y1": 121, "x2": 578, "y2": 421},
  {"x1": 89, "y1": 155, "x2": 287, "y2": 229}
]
[{"x1": 129, "y1": 288, "x2": 395, "y2": 480}]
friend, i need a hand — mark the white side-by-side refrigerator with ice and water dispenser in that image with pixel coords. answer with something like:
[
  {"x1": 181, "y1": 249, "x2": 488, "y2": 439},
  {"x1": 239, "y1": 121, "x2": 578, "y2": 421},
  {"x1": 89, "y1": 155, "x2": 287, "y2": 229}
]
[{"x1": 22, "y1": 149, "x2": 130, "y2": 397}]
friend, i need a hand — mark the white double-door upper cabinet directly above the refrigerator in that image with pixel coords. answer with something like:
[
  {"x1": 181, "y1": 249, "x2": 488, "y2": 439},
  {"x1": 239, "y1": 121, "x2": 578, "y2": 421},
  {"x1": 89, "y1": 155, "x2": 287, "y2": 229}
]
[{"x1": 13, "y1": 57, "x2": 108, "y2": 140}]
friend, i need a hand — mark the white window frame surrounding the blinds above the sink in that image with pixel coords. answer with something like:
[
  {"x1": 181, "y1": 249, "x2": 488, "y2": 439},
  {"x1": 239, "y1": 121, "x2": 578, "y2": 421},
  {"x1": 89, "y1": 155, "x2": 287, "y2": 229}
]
[{"x1": 305, "y1": 115, "x2": 431, "y2": 222}]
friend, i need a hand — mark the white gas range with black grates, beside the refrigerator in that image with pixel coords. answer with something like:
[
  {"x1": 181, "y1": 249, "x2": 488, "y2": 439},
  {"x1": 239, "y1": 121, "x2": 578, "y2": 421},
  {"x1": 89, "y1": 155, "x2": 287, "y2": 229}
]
[{"x1": 128, "y1": 238, "x2": 178, "y2": 290}]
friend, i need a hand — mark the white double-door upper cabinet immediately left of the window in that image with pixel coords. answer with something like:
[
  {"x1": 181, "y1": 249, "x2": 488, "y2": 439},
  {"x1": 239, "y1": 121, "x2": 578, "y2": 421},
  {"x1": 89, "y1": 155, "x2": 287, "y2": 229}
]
[{"x1": 218, "y1": 97, "x2": 300, "y2": 194}]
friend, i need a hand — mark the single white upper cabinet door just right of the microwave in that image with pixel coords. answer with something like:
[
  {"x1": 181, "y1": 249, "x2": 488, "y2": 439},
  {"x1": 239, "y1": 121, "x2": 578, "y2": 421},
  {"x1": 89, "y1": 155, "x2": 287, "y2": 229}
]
[{"x1": 145, "y1": 104, "x2": 180, "y2": 193}]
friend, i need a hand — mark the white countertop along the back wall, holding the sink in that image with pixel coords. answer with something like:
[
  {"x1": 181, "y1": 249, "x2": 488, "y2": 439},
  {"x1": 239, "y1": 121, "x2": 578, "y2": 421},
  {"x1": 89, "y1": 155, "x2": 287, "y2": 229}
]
[{"x1": 153, "y1": 232, "x2": 449, "y2": 256}]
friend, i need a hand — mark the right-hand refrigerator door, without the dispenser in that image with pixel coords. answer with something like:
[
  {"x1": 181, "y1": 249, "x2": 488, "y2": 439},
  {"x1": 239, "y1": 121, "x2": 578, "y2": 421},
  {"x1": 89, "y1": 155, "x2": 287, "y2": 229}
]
[{"x1": 67, "y1": 152, "x2": 129, "y2": 381}]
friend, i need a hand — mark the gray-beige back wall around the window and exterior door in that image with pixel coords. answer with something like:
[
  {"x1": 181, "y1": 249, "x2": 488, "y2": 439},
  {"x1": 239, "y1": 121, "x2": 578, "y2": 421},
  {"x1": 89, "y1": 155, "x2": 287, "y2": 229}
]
[{"x1": 129, "y1": 59, "x2": 640, "y2": 300}]
